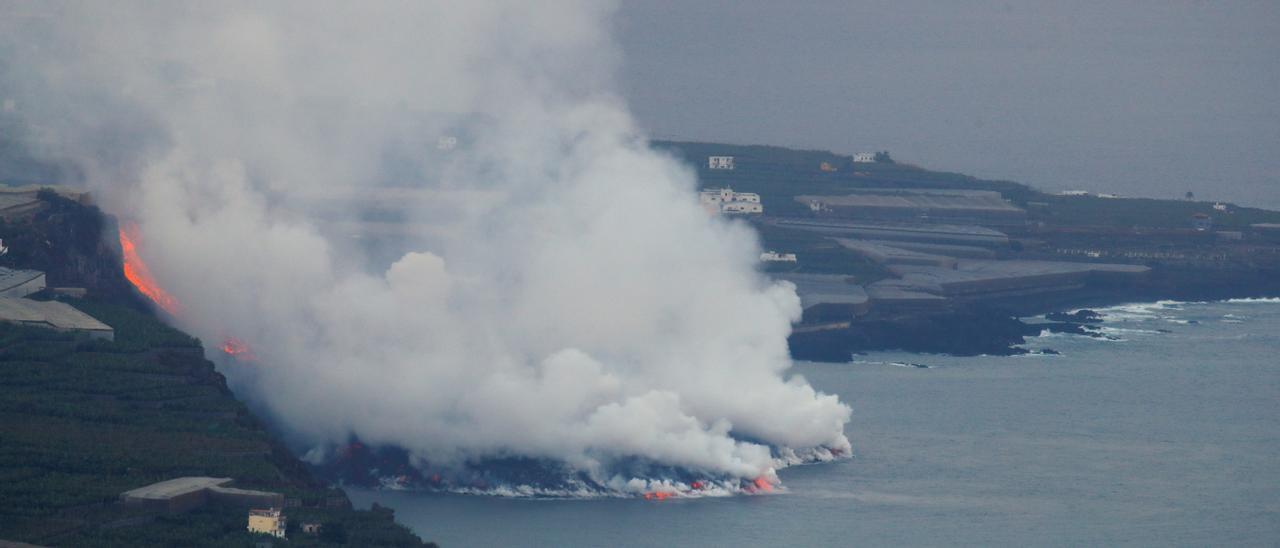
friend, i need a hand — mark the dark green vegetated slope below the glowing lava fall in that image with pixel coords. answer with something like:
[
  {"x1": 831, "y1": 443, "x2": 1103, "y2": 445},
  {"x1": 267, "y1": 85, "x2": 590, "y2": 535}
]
[{"x1": 0, "y1": 301, "x2": 432, "y2": 547}]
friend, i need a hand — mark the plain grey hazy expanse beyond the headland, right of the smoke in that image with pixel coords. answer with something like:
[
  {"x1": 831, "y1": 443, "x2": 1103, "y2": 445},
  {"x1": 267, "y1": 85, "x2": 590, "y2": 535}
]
[{"x1": 617, "y1": 0, "x2": 1280, "y2": 207}]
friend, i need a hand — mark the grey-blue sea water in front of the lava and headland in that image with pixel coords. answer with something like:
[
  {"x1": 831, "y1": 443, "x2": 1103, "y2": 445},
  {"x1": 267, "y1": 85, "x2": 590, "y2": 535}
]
[{"x1": 351, "y1": 300, "x2": 1280, "y2": 547}]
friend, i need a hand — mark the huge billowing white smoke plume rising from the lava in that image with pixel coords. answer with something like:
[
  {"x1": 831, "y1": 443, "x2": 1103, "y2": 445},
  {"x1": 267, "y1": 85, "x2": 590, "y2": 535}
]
[{"x1": 0, "y1": 0, "x2": 850, "y2": 492}]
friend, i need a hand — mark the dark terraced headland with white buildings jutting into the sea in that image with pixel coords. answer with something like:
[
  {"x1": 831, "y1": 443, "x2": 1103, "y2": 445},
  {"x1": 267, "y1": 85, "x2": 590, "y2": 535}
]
[{"x1": 657, "y1": 142, "x2": 1280, "y2": 361}]
